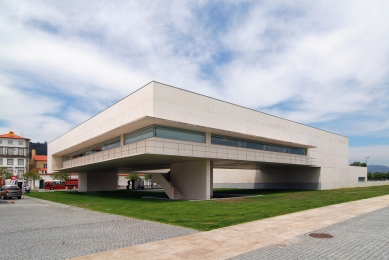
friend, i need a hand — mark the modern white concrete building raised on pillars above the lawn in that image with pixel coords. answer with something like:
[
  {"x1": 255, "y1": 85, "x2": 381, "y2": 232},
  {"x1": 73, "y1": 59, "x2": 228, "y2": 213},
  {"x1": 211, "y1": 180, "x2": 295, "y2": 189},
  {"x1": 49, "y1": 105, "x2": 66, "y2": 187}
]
[{"x1": 48, "y1": 81, "x2": 367, "y2": 199}]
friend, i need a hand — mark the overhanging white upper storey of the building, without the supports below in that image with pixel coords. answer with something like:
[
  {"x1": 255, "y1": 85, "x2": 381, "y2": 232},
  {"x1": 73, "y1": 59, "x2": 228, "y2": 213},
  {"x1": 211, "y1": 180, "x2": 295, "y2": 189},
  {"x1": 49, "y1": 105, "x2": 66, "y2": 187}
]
[{"x1": 48, "y1": 82, "x2": 348, "y2": 173}]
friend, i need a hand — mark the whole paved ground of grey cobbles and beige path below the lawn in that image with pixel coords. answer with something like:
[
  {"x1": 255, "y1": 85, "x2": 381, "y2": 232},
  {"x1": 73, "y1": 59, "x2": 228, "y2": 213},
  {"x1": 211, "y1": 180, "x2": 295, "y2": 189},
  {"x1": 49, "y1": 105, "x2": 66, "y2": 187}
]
[{"x1": 0, "y1": 195, "x2": 389, "y2": 260}]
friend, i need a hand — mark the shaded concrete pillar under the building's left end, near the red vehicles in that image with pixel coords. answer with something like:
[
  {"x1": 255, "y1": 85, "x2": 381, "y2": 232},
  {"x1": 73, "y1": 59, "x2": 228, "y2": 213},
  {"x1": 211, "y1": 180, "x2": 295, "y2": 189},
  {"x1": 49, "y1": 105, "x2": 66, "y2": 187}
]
[{"x1": 78, "y1": 172, "x2": 117, "y2": 192}]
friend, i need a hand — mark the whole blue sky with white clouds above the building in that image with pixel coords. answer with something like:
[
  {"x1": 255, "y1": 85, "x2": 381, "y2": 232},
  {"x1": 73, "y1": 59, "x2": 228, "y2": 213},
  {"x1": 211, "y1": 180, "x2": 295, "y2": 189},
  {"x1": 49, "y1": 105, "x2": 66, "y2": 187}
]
[{"x1": 0, "y1": 0, "x2": 389, "y2": 166}]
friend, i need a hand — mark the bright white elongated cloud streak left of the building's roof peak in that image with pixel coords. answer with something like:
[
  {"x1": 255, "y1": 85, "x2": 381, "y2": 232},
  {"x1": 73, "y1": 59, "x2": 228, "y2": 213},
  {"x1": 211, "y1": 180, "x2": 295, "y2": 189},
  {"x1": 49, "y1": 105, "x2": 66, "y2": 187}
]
[{"x1": 0, "y1": 19, "x2": 145, "y2": 96}]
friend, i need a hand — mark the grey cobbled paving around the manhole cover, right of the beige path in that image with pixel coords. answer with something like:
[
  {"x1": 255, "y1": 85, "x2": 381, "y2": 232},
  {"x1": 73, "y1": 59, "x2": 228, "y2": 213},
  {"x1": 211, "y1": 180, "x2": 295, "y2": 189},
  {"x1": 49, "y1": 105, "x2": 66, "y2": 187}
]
[{"x1": 229, "y1": 207, "x2": 389, "y2": 260}]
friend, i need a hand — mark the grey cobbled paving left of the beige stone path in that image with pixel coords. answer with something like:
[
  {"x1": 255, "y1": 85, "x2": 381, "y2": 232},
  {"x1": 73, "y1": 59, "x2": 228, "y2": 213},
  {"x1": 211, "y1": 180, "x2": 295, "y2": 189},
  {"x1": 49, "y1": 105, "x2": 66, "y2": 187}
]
[{"x1": 0, "y1": 197, "x2": 198, "y2": 259}]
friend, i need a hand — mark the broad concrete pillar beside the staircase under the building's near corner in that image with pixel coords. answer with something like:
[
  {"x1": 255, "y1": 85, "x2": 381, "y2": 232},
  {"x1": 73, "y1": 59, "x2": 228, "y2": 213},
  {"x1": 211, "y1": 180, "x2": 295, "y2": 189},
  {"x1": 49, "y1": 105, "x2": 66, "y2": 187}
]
[{"x1": 170, "y1": 160, "x2": 213, "y2": 200}]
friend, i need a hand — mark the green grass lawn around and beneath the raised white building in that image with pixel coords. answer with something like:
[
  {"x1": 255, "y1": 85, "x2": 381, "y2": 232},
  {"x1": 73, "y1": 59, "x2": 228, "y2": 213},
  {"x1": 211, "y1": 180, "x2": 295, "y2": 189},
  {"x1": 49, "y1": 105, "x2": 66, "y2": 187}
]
[{"x1": 28, "y1": 186, "x2": 389, "y2": 231}]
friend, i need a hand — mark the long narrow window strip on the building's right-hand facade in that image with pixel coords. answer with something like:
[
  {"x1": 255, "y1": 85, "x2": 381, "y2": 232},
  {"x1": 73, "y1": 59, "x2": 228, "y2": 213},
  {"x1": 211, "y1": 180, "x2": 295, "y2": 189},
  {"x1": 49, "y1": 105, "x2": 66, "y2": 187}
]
[{"x1": 211, "y1": 135, "x2": 307, "y2": 155}]
